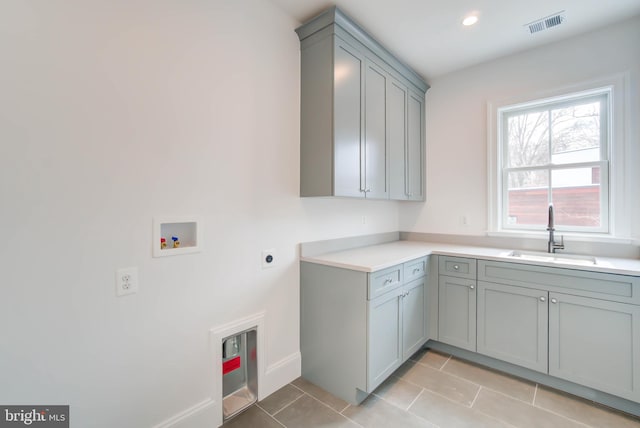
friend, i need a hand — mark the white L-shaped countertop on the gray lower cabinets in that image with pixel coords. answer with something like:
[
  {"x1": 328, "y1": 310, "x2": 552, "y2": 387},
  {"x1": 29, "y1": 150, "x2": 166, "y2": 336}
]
[{"x1": 300, "y1": 241, "x2": 640, "y2": 276}]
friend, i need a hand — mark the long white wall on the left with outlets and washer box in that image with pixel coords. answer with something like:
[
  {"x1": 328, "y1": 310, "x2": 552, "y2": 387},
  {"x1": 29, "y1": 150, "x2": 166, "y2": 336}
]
[{"x1": 0, "y1": 0, "x2": 398, "y2": 428}]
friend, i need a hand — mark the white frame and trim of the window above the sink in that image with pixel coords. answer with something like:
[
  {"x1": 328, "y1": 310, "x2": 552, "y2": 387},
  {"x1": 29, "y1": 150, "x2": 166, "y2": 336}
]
[{"x1": 487, "y1": 73, "x2": 633, "y2": 242}]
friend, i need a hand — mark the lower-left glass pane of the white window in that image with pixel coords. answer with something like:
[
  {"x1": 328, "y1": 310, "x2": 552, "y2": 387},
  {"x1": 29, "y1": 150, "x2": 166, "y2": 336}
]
[{"x1": 507, "y1": 170, "x2": 549, "y2": 227}]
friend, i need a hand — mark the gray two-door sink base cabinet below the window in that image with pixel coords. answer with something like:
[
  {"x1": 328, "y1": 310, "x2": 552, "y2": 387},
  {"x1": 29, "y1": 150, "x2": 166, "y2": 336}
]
[{"x1": 476, "y1": 260, "x2": 640, "y2": 402}]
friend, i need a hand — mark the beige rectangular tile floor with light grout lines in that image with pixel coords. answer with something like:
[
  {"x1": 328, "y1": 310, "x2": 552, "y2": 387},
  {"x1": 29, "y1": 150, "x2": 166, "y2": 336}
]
[{"x1": 224, "y1": 350, "x2": 640, "y2": 428}]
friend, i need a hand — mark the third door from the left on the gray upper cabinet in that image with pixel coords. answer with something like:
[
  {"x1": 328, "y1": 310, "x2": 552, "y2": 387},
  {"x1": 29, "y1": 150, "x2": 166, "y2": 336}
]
[{"x1": 387, "y1": 78, "x2": 409, "y2": 200}]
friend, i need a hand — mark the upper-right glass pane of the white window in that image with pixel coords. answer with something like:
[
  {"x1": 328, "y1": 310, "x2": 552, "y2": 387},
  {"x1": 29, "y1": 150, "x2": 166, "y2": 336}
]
[{"x1": 551, "y1": 102, "x2": 600, "y2": 164}]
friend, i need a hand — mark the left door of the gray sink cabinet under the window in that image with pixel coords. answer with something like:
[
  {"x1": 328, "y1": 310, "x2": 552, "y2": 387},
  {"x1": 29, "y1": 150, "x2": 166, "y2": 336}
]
[{"x1": 477, "y1": 282, "x2": 548, "y2": 373}]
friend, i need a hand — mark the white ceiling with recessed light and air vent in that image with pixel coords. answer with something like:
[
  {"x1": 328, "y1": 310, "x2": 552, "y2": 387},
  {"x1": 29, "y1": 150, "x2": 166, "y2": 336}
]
[{"x1": 271, "y1": 0, "x2": 640, "y2": 79}]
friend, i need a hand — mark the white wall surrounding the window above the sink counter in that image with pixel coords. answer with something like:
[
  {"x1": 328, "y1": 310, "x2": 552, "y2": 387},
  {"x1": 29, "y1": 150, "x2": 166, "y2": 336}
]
[{"x1": 400, "y1": 18, "x2": 640, "y2": 239}]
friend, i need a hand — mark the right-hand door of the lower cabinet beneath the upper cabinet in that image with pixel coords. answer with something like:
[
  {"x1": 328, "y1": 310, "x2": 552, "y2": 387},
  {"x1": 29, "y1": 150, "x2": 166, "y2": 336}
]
[{"x1": 402, "y1": 277, "x2": 427, "y2": 361}]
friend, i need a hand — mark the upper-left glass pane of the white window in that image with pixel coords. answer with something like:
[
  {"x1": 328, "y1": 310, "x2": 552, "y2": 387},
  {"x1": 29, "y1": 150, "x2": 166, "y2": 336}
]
[{"x1": 507, "y1": 111, "x2": 549, "y2": 167}]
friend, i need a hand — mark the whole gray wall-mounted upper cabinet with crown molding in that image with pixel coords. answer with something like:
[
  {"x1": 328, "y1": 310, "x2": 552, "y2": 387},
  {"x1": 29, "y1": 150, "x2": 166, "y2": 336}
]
[{"x1": 296, "y1": 7, "x2": 428, "y2": 200}]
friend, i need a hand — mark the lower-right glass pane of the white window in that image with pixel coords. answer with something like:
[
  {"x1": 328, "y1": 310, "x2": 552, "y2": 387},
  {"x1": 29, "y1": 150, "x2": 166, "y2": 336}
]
[{"x1": 551, "y1": 167, "x2": 602, "y2": 227}]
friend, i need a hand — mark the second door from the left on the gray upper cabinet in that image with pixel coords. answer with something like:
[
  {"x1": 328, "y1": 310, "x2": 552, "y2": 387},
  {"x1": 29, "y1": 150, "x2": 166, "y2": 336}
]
[{"x1": 363, "y1": 61, "x2": 389, "y2": 199}]
